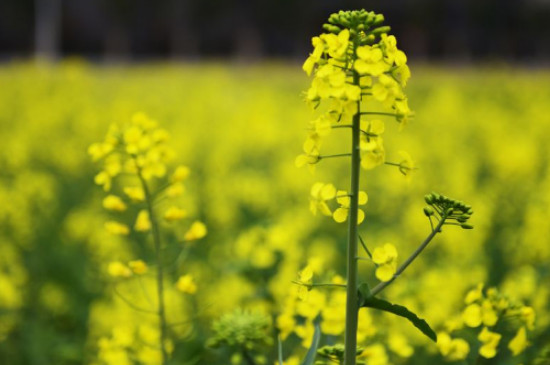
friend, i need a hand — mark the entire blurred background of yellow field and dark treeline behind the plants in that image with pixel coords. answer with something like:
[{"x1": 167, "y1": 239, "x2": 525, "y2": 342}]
[{"x1": 0, "y1": 0, "x2": 550, "y2": 365}]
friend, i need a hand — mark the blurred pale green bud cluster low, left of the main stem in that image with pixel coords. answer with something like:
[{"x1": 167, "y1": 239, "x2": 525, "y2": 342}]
[{"x1": 208, "y1": 309, "x2": 272, "y2": 350}]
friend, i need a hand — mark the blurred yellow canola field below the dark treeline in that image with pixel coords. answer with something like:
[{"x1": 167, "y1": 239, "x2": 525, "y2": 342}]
[{"x1": 0, "y1": 60, "x2": 550, "y2": 365}]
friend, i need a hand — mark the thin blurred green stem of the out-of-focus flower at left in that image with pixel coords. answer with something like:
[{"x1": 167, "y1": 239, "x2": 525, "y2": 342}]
[{"x1": 137, "y1": 168, "x2": 168, "y2": 365}]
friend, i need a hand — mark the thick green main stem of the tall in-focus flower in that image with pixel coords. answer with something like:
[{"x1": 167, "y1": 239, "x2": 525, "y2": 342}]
[{"x1": 344, "y1": 73, "x2": 361, "y2": 365}]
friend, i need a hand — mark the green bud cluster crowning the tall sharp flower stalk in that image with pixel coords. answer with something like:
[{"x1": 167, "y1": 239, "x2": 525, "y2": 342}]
[{"x1": 323, "y1": 9, "x2": 390, "y2": 45}]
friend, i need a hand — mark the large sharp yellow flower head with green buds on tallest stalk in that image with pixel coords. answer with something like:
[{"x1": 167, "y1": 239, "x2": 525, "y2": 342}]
[{"x1": 295, "y1": 10, "x2": 415, "y2": 222}]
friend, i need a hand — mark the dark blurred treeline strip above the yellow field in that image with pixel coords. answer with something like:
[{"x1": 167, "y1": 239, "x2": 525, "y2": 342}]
[{"x1": 0, "y1": 0, "x2": 550, "y2": 62}]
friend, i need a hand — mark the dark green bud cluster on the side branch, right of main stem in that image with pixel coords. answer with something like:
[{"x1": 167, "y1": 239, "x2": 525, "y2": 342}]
[{"x1": 424, "y1": 192, "x2": 474, "y2": 229}]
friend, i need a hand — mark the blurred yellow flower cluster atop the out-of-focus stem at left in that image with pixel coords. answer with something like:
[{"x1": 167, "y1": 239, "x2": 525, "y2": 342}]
[{"x1": 88, "y1": 113, "x2": 207, "y2": 245}]
